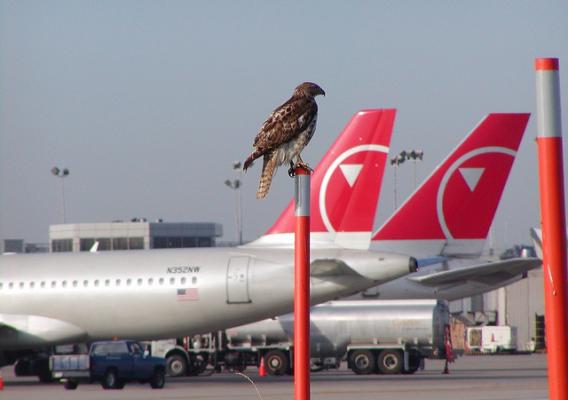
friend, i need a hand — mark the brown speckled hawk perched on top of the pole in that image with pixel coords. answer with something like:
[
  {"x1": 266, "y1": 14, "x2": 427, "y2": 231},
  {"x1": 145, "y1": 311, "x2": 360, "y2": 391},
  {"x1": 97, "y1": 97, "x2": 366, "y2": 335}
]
[{"x1": 243, "y1": 82, "x2": 325, "y2": 199}]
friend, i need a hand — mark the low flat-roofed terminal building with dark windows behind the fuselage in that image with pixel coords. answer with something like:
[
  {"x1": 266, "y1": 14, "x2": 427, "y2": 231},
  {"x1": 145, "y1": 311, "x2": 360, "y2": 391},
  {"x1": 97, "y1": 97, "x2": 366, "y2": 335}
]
[{"x1": 49, "y1": 218, "x2": 223, "y2": 252}]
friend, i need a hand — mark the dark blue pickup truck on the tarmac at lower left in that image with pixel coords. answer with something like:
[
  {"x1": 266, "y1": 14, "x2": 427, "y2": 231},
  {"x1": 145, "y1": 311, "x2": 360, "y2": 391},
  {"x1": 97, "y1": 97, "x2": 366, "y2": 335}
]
[{"x1": 49, "y1": 340, "x2": 166, "y2": 389}]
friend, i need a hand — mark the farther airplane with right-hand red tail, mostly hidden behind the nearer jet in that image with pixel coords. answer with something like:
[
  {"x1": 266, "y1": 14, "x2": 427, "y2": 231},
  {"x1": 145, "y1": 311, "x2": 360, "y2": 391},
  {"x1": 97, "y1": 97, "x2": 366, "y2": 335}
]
[{"x1": 355, "y1": 113, "x2": 541, "y2": 301}]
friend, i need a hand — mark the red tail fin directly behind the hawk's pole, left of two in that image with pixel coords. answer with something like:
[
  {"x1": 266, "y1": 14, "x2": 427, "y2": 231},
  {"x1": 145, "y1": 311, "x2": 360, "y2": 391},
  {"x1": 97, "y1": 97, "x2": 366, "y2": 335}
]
[{"x1": 246, "y1": 109, "x2": 396, "y2": 248}]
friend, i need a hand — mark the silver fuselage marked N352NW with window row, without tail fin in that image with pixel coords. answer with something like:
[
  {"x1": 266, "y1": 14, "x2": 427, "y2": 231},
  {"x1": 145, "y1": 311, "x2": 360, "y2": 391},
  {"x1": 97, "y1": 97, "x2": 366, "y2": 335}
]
[{"x1": 0, "y1": 247, "x2": 411, "y2": 350}]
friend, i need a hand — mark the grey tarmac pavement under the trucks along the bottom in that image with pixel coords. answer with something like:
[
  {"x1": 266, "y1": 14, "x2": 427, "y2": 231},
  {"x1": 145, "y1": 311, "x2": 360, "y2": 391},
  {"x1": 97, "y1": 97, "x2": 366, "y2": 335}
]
[{"x1": 0, "y1": 354, "x2": 548, "y2": 400}]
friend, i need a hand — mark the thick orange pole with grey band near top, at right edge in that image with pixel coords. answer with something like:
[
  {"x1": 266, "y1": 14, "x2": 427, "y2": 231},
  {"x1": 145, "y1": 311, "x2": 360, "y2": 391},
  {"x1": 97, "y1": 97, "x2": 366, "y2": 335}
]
[{"x1": 535, "y1": 58, "x2": 568, "y2": 400}]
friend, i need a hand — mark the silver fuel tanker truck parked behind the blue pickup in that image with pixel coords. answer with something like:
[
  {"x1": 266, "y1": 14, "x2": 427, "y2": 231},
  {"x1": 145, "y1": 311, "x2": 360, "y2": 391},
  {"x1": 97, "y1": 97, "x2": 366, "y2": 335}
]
[{"x1": 151, "y1": 300, "x2": 451, "y2": 376}]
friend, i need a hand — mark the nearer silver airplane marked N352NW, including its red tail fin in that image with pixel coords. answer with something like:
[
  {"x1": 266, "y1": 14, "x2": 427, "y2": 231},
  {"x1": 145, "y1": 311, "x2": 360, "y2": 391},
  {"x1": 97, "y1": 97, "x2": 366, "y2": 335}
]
[{"x1": 0, "y1": 109, "x2": 416, "y2": 374}]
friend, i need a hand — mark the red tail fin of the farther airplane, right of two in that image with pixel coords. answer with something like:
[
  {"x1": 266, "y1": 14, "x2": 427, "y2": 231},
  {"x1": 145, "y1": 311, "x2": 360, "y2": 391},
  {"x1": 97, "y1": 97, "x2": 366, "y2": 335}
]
[{"x1": 373, "y1": 114, "x2": 529, "y2": 257}]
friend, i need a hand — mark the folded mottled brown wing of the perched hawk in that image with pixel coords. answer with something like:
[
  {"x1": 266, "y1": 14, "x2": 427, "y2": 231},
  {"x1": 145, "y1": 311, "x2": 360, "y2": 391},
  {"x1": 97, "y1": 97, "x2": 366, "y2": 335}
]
[{"x1": 254, "y1": 97, "x2": 318, "y2": 154}]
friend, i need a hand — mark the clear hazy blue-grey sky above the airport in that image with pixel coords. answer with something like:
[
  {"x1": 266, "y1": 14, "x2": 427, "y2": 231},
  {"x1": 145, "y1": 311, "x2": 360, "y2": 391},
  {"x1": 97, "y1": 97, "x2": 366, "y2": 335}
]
[{"x1": 0, "y1": 0, "x2": 568, "y2": 250}]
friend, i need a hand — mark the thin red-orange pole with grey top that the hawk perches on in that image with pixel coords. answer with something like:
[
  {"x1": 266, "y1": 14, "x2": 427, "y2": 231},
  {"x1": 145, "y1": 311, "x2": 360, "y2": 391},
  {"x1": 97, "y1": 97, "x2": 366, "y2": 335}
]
[{"x1": 294, "y1": 168, "x2": 310, "y2": 400}]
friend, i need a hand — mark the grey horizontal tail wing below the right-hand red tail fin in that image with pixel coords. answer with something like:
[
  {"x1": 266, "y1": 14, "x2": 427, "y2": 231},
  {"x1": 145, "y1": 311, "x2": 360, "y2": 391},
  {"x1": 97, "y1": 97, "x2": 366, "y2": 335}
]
[{"x1": 408, "y1": 257, "x2": 542, "y2": 286}]
